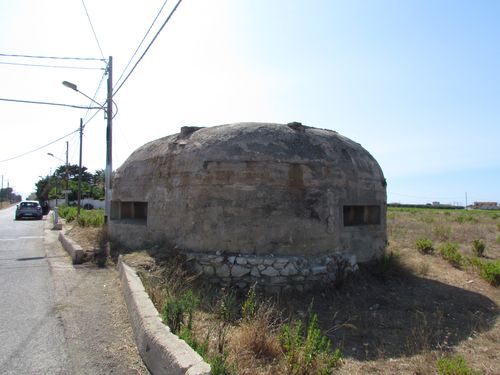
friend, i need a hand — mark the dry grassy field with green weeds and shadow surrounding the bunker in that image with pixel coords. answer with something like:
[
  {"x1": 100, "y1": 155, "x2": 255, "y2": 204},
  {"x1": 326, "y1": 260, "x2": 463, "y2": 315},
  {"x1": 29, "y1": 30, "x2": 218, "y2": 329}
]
[{"x1": 98, "y1": 208, "x2": 500, "y2": 375}]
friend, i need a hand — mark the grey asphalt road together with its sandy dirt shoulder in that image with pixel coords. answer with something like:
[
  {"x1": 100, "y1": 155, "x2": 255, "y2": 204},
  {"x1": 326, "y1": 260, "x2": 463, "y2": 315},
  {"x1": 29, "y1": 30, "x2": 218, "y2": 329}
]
[{"x1": 0, "y1": 207, "x2": 148, "y2": 374}]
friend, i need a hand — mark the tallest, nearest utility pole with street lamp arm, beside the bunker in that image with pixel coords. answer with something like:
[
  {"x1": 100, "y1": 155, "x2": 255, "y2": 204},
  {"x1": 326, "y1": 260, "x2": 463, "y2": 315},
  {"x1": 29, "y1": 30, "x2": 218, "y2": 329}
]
[{"x1": 63, "y1": 56, "x2": 113, "y2": 223}]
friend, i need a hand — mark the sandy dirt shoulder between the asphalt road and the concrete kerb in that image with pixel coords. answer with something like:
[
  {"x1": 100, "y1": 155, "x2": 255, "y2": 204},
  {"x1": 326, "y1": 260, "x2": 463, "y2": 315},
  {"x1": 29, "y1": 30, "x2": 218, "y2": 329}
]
[{"x1": 45, "y1": 222, "x2": 149, "y2": 375}]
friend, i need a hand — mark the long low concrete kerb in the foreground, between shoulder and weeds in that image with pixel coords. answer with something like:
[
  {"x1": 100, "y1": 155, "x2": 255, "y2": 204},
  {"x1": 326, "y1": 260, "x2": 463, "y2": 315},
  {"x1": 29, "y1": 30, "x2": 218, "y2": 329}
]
[{"x1": 118, "y1": 255, "x2": 211, "y2": 375}]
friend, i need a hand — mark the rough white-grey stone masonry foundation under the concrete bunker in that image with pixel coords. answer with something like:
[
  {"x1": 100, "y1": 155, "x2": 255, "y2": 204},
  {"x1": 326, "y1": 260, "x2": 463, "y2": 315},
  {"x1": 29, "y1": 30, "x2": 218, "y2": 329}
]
[{"x1": 186, "y1": 252, "x2": 358, "y2": 292}]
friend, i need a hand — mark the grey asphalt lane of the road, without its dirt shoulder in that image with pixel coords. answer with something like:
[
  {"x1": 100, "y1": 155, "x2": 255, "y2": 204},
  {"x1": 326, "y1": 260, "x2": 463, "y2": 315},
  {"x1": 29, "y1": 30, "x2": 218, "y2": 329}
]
[{"x1": 0, "y1": 208, "x2": 71, "y2": 374}]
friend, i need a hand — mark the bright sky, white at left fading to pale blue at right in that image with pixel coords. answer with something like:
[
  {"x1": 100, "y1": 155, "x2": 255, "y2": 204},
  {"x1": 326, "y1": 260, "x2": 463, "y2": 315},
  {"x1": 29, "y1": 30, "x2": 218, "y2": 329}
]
[{"x1": 0, "y1": 0, "x2": 500, "y2": 205}]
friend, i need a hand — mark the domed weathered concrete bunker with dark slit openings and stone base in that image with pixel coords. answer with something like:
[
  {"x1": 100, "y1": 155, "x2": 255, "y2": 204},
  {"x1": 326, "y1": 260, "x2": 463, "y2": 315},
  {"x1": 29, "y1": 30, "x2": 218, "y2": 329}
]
[{"x1": 109, "y1": 123, "x2": 387, "y2": 289}]
